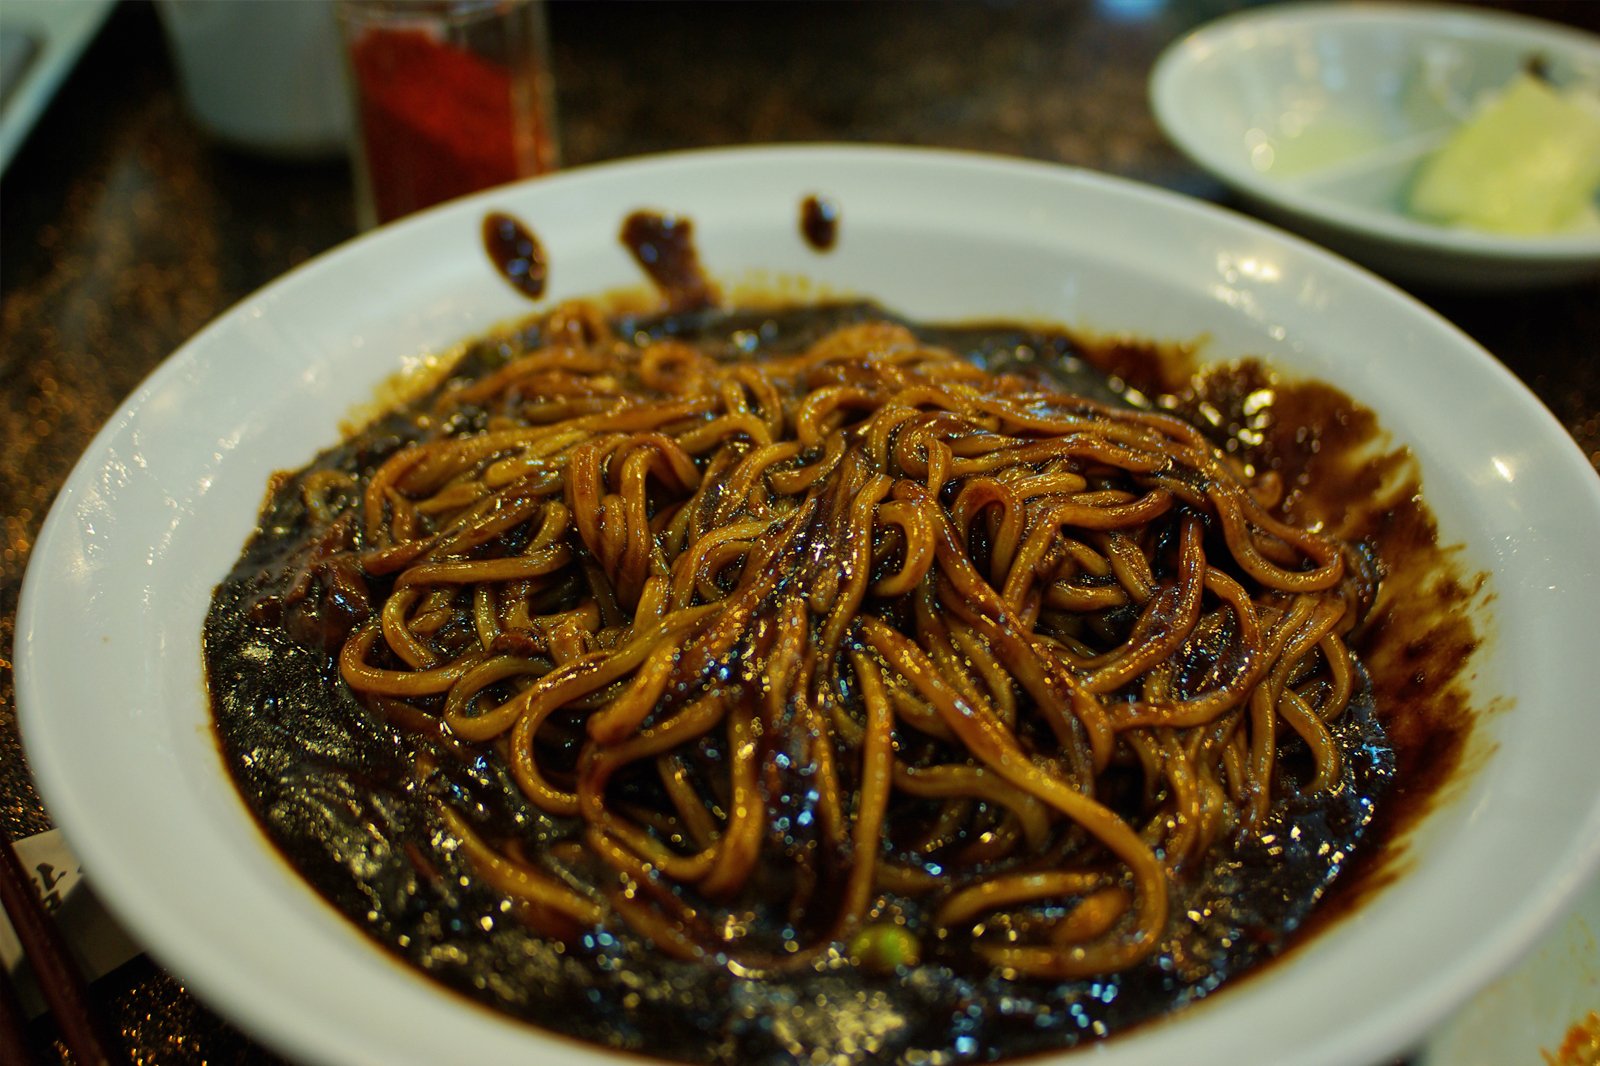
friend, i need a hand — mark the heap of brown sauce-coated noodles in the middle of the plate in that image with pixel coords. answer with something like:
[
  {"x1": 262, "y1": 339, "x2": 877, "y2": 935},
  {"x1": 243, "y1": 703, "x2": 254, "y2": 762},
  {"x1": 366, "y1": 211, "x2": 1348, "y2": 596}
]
[{"x1": 315, "y1": 306, "x2": 1371, "y2": 978}]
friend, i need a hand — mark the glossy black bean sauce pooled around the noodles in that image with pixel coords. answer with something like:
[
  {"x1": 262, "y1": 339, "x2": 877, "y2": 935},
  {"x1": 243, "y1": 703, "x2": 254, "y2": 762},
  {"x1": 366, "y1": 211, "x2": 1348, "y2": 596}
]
[{"x1": 205, "y1": 299, "x2": 1427, "y2": 1066}]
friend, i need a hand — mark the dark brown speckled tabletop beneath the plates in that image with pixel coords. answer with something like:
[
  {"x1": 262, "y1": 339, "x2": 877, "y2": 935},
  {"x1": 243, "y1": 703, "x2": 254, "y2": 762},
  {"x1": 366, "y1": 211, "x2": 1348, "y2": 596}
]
[{"x1": 0, "y1": 0, "x2": 1600, "y2": 1063}]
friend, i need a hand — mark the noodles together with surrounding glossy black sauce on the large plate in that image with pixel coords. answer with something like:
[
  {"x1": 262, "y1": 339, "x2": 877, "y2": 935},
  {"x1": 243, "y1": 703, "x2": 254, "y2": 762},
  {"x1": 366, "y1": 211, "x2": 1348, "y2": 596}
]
[{"x1": 206, "y1": 294, "x2": 1465, "y2": 1063}]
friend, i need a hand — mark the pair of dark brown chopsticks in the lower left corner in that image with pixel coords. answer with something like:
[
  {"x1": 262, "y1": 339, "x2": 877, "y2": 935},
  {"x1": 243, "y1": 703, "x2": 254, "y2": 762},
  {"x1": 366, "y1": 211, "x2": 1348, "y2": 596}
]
[{"x1": 0, "y1": 837, "x2": 122, "y2": 1066}]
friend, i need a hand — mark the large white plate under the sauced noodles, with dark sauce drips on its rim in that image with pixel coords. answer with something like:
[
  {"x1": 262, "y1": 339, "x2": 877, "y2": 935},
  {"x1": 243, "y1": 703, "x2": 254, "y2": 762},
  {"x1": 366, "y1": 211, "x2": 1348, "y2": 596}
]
[{"x1": 16, "y1": 147, "x2": 1600, "y2": 1066}]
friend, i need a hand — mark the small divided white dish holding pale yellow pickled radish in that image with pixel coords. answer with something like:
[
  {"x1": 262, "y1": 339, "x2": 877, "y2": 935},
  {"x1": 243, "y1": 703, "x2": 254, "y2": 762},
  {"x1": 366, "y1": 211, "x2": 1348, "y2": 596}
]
[{"x1": 1150, "y1": 3, "x2": 1600, "y2": 288}]
